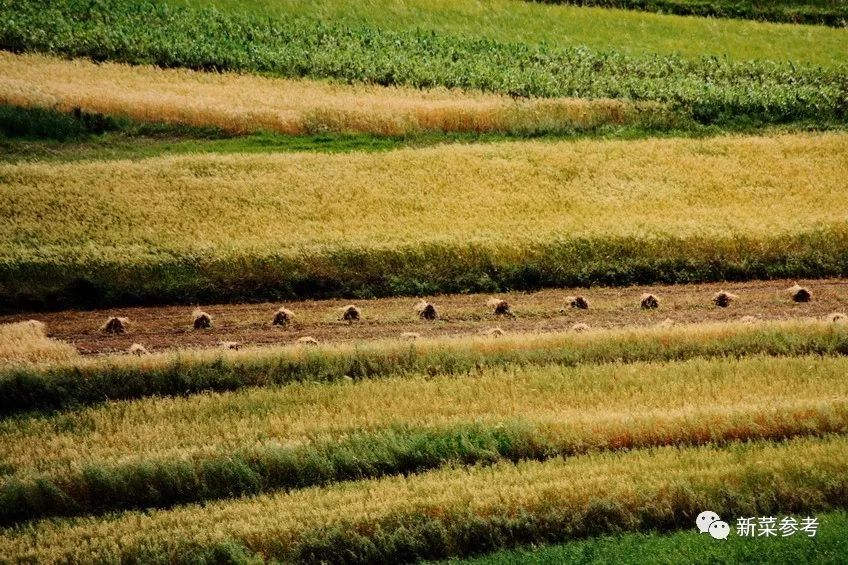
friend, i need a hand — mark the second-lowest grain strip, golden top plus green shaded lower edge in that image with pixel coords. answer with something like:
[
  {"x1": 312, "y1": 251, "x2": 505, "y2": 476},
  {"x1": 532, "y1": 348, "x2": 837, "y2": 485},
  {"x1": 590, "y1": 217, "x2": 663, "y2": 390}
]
[{"x1": 0, "y1": 357, "x2": 848, "y2": 523}]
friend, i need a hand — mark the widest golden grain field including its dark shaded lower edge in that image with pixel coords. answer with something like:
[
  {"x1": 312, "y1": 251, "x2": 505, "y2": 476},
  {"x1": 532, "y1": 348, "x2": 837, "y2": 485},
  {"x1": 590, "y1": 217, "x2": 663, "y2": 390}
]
[{"x1": 0, "y1": 133, "x2": 848, "y2": 309}]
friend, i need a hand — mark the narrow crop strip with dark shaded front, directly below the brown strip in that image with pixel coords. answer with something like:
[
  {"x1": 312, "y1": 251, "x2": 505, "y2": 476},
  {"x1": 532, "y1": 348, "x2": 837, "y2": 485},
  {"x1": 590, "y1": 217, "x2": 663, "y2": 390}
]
[{"x1": 0, "y1": 322, "x2": 848, "y2": 417}]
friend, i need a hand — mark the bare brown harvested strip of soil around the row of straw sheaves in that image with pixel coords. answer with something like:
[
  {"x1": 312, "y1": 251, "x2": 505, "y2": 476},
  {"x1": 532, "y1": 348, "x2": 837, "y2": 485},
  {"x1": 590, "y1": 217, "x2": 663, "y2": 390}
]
[{"x1": 0, "y1": 279, "x2": 848, "y2": 353}]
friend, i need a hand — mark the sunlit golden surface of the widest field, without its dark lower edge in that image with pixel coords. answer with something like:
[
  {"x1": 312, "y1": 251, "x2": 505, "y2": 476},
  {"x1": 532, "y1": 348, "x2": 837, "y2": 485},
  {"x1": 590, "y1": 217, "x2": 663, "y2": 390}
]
[{"x1": 0, "y1": 133, "x2": 848, "y2": 269}]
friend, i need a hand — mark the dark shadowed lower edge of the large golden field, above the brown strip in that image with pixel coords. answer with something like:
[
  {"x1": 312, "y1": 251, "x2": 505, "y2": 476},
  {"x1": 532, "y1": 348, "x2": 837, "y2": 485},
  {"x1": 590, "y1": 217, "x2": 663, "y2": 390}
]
[{"x1": 0, "y1": 225, "x2": 848, "y2": 313}]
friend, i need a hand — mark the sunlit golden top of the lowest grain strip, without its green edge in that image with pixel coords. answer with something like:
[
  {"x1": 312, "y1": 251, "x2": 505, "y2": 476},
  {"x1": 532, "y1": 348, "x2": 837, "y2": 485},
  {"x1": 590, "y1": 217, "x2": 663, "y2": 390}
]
[{"x1": 0, "y1": 437, "x2": 848, "y2": 563}]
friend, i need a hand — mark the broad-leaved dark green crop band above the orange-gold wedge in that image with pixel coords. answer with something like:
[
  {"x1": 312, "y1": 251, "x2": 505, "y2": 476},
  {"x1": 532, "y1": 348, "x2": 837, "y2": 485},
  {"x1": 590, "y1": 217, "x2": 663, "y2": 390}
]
[{"x1": 0, "y1": 0, "x2": 848, "y2": 130}]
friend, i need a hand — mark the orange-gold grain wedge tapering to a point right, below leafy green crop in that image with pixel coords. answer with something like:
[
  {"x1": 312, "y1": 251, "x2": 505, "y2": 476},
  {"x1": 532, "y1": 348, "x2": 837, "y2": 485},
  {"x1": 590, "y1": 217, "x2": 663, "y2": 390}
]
[{"x1": 0, "y1": 53, "x2": 662, "y2": 135}]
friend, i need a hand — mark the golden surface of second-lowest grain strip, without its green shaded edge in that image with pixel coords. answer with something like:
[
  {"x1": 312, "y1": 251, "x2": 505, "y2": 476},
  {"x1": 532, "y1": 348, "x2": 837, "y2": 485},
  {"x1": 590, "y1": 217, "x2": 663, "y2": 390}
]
[{"x1": 0, "y1": 354, "x2": 848, "y2": 473}]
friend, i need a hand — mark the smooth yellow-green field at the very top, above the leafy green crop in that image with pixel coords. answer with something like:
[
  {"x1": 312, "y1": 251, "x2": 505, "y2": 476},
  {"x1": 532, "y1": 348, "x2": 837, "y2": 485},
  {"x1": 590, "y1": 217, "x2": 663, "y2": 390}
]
[{"x1": 171, "y1": 0, "x2": 846, "y2": 66}]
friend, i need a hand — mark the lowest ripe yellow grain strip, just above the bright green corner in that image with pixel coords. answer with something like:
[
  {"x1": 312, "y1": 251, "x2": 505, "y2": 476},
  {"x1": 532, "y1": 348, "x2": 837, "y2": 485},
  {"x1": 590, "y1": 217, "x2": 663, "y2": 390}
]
[{"x1": 0, "y1": 437, "x2": 848, "y2": 563}]
